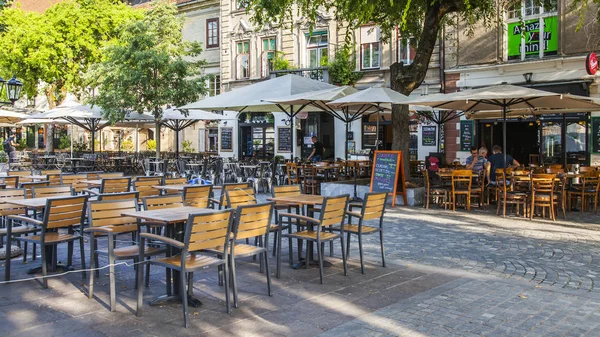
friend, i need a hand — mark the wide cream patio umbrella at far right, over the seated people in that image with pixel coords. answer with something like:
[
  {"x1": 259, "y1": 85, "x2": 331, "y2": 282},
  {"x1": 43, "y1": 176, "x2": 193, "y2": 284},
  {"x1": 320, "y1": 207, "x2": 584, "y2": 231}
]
[{"x1": 408, "y1": 84, "x2": 600, "y2": 166}]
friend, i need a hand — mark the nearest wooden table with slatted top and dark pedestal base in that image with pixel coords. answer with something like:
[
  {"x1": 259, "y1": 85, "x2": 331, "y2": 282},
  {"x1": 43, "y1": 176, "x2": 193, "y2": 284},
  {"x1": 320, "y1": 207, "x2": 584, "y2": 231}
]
[{"x1": 121, "y1": 206, "x2": 215, "y2": 307}]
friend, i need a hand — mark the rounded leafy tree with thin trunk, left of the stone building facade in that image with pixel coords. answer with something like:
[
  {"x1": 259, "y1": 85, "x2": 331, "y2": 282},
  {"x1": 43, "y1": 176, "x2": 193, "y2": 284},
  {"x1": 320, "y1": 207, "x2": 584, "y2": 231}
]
[{"x1": 90, "y1": 1, "x2": 207, "y2": 157}]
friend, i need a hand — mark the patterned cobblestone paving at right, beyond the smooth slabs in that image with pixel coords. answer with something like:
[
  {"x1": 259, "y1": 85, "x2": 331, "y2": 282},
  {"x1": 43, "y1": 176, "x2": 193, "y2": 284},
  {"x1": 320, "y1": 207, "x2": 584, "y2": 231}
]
[{"x1": 354, "y1": 208, "x2": 600, "y2": 292}]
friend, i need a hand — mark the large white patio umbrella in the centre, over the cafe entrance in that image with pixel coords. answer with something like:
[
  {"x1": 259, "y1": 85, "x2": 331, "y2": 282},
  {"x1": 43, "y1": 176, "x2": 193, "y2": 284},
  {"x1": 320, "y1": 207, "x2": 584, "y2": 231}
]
[{"x1": 178, "y1": 74, "x2": 336, "y2": 160}]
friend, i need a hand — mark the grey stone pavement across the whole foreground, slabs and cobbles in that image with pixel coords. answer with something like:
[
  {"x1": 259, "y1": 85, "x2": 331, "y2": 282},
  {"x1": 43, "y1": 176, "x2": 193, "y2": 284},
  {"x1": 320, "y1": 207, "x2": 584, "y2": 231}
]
[{"x1": 0, "y1": 197, "x2": 600, "y2": 336}]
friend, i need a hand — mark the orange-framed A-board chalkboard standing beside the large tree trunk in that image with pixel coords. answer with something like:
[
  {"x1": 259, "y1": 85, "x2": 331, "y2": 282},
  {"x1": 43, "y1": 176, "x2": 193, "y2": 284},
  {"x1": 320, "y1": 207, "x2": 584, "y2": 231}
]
[{"x1": 370, "y1": 151, "x2": 406, "y2": 206}]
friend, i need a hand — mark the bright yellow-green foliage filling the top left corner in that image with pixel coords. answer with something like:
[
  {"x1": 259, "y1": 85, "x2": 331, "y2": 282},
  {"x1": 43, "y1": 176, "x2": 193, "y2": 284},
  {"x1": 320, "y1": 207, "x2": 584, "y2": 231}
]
[{"x1": 0, "y1": 0, "x2": 140, "y2": 105}]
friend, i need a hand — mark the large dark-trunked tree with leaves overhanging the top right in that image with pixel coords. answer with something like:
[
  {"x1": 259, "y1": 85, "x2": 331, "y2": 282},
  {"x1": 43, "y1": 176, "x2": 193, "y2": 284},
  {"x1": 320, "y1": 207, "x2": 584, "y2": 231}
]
[{"x1": 249, "y1": 0, "x2": 552, "y2": 172}]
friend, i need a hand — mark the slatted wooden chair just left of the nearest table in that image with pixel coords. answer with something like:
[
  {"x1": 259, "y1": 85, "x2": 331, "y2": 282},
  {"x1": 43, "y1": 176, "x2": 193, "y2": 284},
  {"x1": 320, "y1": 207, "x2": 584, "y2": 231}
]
[{"x1": 84, "y1": 198, "x2": 164, "y2": 311}]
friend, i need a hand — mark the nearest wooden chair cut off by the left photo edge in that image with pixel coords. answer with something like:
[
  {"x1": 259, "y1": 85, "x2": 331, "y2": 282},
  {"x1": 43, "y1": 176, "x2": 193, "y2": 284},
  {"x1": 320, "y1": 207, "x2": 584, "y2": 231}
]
[{"x1": 0, "y1": 188, "x2": 37, "y2": 262}]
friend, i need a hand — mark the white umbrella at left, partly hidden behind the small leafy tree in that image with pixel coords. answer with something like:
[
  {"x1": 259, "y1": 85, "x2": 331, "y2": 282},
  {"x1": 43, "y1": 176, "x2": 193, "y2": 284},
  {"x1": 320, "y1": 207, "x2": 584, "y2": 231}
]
[{"x1": 31, "y1": 100, "x2": 153, "y2": 153}]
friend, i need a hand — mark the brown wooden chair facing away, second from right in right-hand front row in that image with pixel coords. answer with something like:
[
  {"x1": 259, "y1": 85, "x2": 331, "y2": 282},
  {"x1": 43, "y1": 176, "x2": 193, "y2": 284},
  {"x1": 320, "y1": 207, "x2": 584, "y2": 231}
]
[{"x1": 529, "y1": 174, "x2": 560, "y2": 221}]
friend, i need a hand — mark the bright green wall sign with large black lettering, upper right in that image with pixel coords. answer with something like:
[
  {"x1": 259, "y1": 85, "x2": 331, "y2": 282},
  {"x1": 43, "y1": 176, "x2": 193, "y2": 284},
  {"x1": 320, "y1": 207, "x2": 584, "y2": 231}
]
[{"x1": 508, "y1": 16, "x2": 558, "y2": 60}]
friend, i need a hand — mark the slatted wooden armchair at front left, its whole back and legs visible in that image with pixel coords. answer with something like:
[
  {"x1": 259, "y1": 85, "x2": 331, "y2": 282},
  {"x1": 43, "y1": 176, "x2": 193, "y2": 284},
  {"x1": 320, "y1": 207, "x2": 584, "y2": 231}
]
[{"x1": 6, "y1": 196, "x2": 87, "y2": 288}]
